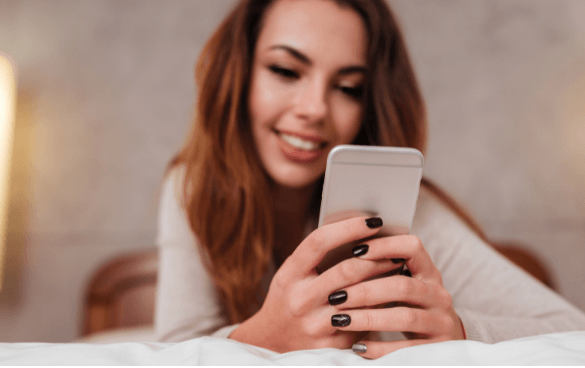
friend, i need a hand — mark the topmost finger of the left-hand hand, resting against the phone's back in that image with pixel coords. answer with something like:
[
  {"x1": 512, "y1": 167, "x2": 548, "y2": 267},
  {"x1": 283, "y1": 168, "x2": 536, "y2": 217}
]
[{"x1": 286, "y1": 216, "x2": 381, "y2": 276}]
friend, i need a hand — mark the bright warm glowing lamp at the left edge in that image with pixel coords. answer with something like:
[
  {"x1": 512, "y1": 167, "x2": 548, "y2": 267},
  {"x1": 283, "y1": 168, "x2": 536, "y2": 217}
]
[{"x1": 0, "y1": 53, "x2": 16, "y2": 291}]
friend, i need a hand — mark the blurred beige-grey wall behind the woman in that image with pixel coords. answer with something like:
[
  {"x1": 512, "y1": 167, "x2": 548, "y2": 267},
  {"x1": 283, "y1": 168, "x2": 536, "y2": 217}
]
[{"x1": 0, "y1": 0, "x2": 585, "y2": 342}]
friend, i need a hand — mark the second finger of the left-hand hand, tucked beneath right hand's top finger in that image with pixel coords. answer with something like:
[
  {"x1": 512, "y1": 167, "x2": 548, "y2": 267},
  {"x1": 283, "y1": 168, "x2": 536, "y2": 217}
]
[{"x1": 311, "y1": 258, "x2": 402, "y2": 302}]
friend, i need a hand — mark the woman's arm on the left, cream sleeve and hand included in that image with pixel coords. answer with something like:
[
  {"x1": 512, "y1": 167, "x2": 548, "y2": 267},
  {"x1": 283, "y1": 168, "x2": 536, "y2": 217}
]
[{"x1": 155, "y1": 168, "x2": 402, "y2": 352}]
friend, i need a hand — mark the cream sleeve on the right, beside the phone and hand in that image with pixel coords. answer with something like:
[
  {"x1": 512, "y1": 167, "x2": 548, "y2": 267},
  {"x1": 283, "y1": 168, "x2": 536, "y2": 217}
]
[{"x1": 412, "y1": 187, "x2": 585, "y2": 343}]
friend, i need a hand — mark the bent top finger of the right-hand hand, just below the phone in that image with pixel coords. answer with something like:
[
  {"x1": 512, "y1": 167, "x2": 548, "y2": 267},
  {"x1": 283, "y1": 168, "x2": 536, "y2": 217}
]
[{"x1": 359, "y1": 235, "x2": 442, "y2": 285}]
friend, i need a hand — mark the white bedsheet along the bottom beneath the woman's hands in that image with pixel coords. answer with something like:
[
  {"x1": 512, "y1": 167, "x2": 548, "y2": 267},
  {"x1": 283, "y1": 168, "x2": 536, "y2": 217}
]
[{"x1": 0, "y1": 331, "x2": 585, "y2": 365}]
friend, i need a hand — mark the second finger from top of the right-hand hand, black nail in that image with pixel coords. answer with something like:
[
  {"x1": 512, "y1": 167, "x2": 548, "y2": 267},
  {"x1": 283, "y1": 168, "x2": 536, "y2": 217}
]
[{"x1": 330, "y1": 276, "x2": 452, "y2": 309}]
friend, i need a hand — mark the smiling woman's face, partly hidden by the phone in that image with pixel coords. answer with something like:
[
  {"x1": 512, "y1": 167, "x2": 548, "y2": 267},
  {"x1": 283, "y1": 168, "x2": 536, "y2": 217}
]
[{"x1": 248, "y1": 0, "x2": 367, "y2": 188}]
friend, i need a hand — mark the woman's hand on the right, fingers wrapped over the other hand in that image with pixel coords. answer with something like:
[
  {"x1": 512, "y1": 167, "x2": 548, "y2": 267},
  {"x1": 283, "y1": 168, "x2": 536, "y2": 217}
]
[{"x1": 326, "y1": 235, "x2": 465, "y2": 359}]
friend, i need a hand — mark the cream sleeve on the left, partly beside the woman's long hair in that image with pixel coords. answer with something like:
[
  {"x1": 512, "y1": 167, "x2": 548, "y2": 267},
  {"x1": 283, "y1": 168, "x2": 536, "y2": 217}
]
[{"x1": 155, "y1": 169, "x2": 231, "y2": 342}]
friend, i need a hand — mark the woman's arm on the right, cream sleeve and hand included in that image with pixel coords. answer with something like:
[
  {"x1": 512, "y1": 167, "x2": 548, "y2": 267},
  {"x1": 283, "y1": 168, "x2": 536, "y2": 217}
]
[{"x1": 334, "y1": 187, "x2": 585, "y2": 359}]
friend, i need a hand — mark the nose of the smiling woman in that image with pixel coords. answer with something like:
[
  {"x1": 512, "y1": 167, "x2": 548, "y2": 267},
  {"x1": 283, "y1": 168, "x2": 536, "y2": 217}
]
[{"x1": 295, "y1": 80, "x2": 329, "y2": 122}]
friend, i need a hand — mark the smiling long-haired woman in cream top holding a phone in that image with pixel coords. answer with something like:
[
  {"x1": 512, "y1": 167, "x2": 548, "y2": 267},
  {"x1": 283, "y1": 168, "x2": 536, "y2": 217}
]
[{"x1": 156, "y1": 0, "x2": 585, "y2": 358}]
